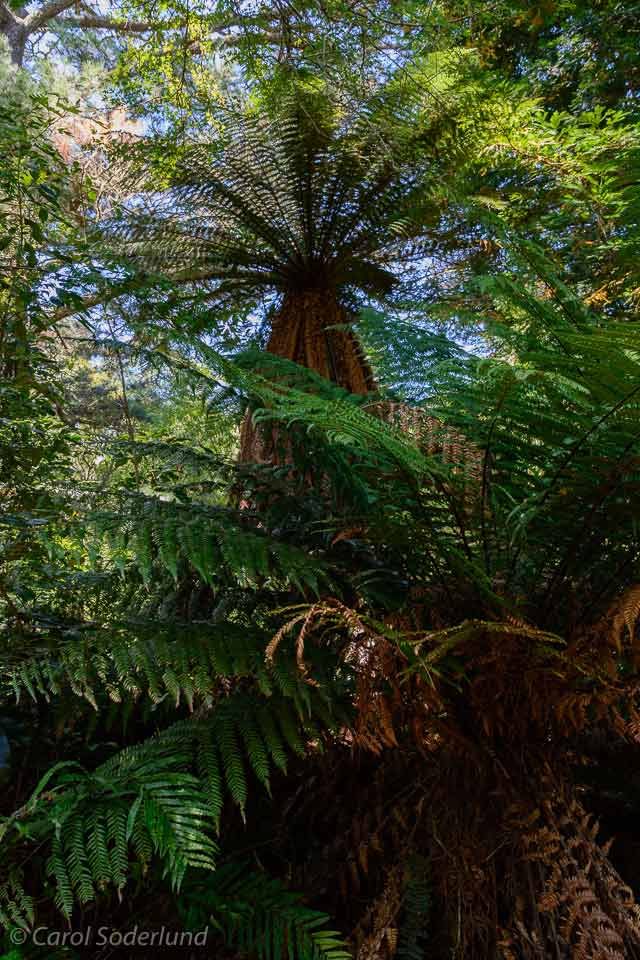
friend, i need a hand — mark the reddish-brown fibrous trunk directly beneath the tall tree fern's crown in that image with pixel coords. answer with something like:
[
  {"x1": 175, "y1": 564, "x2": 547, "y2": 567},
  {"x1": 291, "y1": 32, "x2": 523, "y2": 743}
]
[{"x1": 240, "y1": 290, "x2": 376, "y2": 463}]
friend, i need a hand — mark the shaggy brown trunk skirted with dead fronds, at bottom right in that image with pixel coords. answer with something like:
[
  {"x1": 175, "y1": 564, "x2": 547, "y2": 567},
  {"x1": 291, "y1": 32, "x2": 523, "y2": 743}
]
[{"x1": 281, "y1": 740, "x2": 640, "y2": 960}]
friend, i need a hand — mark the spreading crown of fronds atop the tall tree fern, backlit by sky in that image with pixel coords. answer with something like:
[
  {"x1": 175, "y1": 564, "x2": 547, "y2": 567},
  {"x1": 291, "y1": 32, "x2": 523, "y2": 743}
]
[{"x1": 115, "y1": 84, "x2": 450, "y2": 308}]
